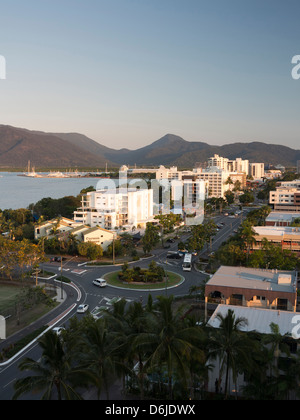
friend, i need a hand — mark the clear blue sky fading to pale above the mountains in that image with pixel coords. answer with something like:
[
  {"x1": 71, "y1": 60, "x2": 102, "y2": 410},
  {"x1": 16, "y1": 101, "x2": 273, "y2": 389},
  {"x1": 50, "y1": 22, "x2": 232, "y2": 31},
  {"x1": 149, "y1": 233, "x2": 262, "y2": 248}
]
[{"x1": 0, "y1": 0, "x2": 300, "y2": 149}]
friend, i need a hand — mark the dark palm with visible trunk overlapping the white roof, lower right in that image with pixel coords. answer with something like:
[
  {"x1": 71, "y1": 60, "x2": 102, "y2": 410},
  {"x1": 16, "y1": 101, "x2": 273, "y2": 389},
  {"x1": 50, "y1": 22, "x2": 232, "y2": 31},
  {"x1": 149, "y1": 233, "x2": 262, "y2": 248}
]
[{"x1": 209, "y1": 309, "x2": 252, "y2": 398}]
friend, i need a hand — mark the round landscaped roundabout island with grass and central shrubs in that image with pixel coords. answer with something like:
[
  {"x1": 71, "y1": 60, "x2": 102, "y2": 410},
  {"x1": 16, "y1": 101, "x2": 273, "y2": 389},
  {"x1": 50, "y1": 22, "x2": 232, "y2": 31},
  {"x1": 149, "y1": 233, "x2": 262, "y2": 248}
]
[{"x1": 104, "y1": 261, "x2": 184, "y2": 290}]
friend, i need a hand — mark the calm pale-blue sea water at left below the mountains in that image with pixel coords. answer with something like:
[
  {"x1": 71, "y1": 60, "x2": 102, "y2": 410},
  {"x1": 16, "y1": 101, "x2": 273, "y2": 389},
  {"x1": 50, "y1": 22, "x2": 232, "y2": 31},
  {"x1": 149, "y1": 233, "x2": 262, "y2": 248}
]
[{"x1": 0, "y1": 172, "x2": 103, "y2": 210}]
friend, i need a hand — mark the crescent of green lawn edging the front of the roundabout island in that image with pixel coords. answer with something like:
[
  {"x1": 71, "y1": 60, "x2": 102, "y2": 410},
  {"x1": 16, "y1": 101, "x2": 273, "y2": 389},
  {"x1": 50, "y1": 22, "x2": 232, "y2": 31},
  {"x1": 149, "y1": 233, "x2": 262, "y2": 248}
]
[{"x1": 104, "y1": 271, "x2": 182, "y2": 290}]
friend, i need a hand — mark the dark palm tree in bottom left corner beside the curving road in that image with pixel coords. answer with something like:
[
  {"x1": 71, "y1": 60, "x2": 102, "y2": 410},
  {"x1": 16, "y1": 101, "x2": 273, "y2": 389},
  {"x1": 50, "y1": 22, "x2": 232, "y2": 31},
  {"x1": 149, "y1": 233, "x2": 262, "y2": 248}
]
[{"x1": 13, "y1": 331, "x2": 82, "y2": 400}]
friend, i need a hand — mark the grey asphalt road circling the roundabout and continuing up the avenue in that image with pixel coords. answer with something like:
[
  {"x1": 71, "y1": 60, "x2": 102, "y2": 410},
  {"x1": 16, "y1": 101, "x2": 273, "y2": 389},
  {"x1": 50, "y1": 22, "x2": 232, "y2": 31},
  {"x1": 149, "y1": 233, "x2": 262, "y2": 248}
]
[{"x1": 0, "y1": 215, "x2": 242, "y2": 400}]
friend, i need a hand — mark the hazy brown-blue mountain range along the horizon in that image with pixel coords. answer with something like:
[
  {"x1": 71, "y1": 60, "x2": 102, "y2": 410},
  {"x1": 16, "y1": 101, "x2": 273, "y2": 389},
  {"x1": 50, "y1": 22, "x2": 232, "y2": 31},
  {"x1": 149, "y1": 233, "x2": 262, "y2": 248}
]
[{"x1": 0, "y1": 125, "x2": 300, "y2": 169}]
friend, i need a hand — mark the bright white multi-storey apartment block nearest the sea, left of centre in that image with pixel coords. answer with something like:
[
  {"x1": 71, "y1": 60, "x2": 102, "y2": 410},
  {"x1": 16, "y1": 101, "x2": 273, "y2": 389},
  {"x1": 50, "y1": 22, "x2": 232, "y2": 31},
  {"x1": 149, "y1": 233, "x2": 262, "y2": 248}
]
[{"x1": 74, "y1": 188, "x2": 153, "y2": 230}]
